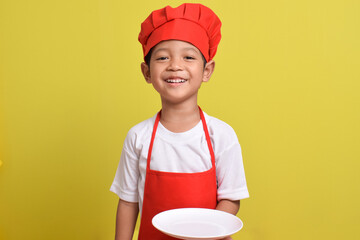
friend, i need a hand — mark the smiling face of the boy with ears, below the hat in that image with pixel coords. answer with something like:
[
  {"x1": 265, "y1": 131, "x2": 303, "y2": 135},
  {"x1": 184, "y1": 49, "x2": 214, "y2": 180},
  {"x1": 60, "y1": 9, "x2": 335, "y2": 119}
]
[{"x1": 141, "y1": 40, "x2": 215, "y2": 103}]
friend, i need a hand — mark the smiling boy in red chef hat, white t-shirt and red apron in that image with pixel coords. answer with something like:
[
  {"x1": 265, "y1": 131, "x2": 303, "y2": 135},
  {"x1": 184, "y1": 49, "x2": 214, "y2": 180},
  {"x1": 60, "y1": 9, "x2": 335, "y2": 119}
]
[{"x1": 111, "y1": 4, "x2": 249, "y2": 240}]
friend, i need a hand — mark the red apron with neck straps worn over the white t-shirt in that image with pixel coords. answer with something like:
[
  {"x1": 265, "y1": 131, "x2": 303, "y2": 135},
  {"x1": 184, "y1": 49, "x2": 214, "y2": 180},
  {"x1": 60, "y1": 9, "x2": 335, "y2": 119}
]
[{"x1": 138, "y1": 107, "x2": 217, "y2": 240}]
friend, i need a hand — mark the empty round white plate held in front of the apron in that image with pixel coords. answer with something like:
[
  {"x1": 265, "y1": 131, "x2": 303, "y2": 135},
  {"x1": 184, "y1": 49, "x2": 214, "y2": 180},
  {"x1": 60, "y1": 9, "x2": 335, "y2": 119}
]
[{"x1": 152, "y1": 208, "x2": 243, "y2": 240}]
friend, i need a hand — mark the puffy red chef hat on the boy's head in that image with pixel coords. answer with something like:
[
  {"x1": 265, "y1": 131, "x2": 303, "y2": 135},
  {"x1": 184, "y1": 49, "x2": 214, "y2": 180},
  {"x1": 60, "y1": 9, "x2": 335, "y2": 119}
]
[{"x1": 138, "y1": 3, "x2": 221, "y2": 62}]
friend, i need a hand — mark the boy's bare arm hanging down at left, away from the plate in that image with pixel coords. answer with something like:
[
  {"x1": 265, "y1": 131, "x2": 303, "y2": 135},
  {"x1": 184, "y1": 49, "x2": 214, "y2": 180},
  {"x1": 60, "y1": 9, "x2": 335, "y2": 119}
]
[{"x1": 115, "y1": 199, "x2": 139, "y2": 240}]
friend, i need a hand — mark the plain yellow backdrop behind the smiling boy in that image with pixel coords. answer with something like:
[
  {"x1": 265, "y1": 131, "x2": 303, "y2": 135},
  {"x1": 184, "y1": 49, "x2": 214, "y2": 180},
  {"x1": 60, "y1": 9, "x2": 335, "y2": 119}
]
[{"x1": 0, "y1": 0, "x2": 360, "y2": 240}]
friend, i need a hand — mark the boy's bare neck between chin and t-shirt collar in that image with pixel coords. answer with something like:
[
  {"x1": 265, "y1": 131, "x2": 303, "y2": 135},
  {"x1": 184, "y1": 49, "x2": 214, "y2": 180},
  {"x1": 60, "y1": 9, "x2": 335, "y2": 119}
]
[{"x1": 160, "y1": 99, "x2": 200, "y2": 132}]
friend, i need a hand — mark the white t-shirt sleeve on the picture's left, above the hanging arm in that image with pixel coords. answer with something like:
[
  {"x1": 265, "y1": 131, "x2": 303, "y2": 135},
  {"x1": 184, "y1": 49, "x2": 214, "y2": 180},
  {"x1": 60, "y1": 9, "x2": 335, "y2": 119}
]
[{"x1": 110, "y1": 131, "x2": 139, "y2": 202}]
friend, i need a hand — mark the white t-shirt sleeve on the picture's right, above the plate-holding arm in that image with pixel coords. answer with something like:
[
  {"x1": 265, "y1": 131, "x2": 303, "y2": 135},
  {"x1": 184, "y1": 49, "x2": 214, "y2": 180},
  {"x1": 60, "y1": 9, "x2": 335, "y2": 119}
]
[{"x1": 216, "y1": 133, "x2": 249, "y2": 201}]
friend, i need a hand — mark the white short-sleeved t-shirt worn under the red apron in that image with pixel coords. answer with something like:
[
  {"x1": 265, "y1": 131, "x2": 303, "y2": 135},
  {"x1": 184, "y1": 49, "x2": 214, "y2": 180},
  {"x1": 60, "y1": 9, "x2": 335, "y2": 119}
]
[{"x1": 110, "y1": 113, "x2": 249, "y2": 211}]
